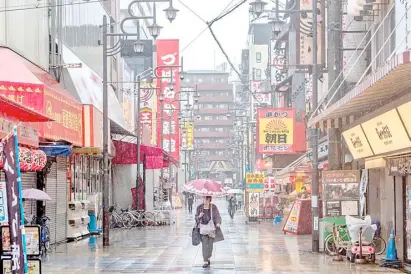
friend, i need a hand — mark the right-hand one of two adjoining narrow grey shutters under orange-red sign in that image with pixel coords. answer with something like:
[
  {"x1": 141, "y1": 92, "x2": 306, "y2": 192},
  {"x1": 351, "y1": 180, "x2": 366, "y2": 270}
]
[{"x1": 56, "y1": 157, "x2": 67, "y2": 242}]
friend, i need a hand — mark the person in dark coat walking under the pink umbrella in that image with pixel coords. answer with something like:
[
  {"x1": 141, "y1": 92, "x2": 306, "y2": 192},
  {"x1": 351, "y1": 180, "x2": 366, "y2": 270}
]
[{"x1": 195, "y1": 196, "x2": 224, "y2": 268}]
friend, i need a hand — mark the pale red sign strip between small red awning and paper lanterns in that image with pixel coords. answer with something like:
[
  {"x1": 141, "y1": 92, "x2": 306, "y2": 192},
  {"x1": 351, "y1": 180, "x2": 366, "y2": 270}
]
[{"x1": 0, "y1": 115, "x2": 39, "y2": 147}]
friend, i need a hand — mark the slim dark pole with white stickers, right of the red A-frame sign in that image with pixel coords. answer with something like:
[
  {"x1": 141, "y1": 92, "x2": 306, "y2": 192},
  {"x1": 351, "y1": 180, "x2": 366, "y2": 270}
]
[{"x1": 311, "y1": 1, "x2": 320, "y2": 252}]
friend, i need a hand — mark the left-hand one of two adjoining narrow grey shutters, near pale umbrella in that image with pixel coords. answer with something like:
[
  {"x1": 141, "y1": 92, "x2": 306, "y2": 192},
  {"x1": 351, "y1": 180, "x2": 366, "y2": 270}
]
[{"x1": 46, "y1": 163, "x2": 57, "y2": 244}]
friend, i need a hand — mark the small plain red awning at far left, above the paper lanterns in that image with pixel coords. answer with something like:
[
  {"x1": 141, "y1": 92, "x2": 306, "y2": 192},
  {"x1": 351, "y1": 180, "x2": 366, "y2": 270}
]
[{"x1": 0, "y1": 95, "x2": 53, "y2": 122}]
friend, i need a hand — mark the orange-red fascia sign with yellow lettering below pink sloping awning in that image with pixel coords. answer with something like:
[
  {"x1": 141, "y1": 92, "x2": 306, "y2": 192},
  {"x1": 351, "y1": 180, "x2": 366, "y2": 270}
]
[{"x1": 0, "y1": 82, "x2": 83, "y2": 146}]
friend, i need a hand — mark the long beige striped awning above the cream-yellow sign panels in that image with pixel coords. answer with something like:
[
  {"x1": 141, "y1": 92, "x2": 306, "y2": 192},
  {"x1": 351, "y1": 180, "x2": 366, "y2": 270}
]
[{"x1": 308, "y1": 51, "x2": 411, "y2": 128}]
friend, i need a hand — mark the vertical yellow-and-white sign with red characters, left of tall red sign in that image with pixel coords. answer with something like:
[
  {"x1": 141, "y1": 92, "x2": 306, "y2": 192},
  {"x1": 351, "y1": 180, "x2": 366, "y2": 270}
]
[{"x1": 140, "y1": 82, "x2": 156, "y2": 140}]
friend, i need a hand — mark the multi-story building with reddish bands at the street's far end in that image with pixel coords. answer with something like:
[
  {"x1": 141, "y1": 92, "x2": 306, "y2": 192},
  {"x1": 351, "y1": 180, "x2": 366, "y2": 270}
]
[{"x1": 184, "y1": 70, "x2": 234, "y2": 181}]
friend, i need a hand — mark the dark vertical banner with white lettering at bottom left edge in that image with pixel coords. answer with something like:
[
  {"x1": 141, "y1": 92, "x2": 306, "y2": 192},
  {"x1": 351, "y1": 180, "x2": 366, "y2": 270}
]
[{"x1": 2, "y1": 132, "x2": 27, "y2": 274}]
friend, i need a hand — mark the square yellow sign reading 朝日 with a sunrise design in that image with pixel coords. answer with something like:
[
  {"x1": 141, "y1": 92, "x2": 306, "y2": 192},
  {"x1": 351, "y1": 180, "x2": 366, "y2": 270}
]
[{"x1": 257, "y1": 108, "x2": 296, "y2": 155}]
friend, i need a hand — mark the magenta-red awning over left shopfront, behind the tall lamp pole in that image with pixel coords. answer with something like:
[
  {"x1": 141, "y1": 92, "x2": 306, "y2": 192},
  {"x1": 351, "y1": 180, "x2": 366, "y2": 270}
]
[{"x1": 112, "y1": 140, "x2": 177, "y2": 169}]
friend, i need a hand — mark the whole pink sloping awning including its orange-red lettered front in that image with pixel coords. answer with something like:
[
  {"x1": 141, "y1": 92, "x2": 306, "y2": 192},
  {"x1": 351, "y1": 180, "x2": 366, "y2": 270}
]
[{"x1": 0, "y1": 48, "x2": 83, "y2": 146}]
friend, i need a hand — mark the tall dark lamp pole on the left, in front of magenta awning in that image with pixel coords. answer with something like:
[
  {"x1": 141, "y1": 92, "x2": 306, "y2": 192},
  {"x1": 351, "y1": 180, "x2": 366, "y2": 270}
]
[{"x1": 103, "y1": 15, "x2": 110, "y2": 247}]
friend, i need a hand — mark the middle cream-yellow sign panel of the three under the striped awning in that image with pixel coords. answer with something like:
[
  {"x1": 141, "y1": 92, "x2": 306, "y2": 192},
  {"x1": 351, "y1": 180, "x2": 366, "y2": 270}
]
[{"x1": 361, "y1": 109, "x2": 411, "y2": 154}]
